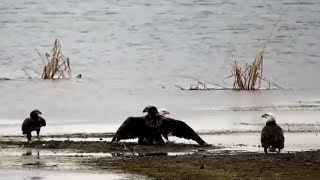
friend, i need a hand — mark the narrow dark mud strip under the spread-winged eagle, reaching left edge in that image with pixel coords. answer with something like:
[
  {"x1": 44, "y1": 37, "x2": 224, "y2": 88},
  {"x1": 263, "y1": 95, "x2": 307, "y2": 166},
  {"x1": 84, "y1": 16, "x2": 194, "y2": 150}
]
[{"x1": 0, "y1": 140, "x2": 216, "y2": 155}]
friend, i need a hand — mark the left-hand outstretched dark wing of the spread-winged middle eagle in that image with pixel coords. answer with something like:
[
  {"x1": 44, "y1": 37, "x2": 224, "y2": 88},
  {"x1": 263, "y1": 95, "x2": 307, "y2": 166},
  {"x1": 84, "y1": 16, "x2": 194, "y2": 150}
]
[{"x1": 111, "y1": 117, "x2": 145, "y2": 142}]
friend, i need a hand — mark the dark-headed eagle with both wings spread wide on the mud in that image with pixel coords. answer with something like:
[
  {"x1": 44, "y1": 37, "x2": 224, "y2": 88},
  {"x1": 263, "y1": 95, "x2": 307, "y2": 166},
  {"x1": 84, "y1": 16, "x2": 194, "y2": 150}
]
[{"x1": 112, "y1": 106, "x2": 208, "y2": 146}]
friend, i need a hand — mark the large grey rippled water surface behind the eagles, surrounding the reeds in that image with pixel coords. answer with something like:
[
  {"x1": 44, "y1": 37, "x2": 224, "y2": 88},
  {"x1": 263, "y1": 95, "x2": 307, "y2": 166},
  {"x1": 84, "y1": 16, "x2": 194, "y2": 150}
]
[{"x1": 0, "y1": 0, "x2": 320, "y2": 138}]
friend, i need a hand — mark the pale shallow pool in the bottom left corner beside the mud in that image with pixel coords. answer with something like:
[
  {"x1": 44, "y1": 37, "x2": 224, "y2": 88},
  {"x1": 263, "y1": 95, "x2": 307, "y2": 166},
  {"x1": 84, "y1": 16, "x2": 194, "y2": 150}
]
[{"x1": 0, "y1": 147, "x2": 146, "y2": 180}]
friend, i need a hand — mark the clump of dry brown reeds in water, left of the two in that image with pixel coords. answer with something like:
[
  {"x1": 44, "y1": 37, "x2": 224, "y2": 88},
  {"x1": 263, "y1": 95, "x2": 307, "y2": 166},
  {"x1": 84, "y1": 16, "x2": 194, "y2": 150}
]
[{"x1": 38, "y1": 39, "x2": 71, "y2": 79}]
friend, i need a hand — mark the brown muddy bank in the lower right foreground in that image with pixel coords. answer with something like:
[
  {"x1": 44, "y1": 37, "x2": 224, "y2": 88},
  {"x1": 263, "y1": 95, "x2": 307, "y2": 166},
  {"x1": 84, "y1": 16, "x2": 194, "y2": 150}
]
[{"x1": 86, "y1": 151, "x2": 320, "y2": 180}]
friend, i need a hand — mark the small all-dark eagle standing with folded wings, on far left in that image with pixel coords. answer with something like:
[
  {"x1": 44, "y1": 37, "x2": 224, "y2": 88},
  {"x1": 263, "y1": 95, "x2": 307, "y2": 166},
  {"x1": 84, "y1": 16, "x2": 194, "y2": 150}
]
[{"x1": 21, "y1": 109, "x2": 47, "y2": 141}]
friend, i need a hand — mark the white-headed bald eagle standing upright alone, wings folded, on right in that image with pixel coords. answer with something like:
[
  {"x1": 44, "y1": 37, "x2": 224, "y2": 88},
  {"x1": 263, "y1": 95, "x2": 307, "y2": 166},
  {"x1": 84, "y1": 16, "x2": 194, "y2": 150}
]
[{"x1": 261, "y1": 113, "x2": 284, "y2": 154}]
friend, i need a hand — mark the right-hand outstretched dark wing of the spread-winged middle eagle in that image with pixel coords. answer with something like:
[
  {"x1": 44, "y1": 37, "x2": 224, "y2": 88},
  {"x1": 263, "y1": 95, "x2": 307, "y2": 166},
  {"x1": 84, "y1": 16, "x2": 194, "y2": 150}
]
[{"x1": 160, "y1": 117, "x2": 208, "y2": 146}]
